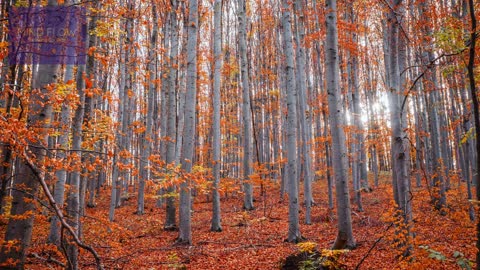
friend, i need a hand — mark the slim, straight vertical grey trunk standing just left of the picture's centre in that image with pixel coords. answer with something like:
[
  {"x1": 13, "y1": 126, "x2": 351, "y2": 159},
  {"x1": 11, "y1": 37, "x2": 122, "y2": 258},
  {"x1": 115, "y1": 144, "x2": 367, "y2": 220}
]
[{"x1": 211, "y1": 0, "x2": 222, "y2": 232}]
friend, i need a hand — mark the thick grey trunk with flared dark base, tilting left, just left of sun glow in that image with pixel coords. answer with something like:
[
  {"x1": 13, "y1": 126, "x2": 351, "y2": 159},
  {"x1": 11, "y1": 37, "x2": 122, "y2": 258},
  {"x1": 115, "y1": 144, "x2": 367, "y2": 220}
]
[{"x1": 325, "y1": 0, "x2": 356, "y2": 249}]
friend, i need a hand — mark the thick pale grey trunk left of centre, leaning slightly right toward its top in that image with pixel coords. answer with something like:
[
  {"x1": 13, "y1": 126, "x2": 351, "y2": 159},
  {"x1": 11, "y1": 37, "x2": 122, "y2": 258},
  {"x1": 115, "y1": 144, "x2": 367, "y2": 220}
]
[{"x1": 177, "y1": 0, "x2": 199, "y2": 245}]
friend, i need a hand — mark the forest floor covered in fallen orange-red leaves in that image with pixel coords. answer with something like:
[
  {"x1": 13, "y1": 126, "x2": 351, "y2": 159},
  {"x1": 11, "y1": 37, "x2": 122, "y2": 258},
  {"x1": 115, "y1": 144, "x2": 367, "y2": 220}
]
[{"x1": 9, "y1": 175, "x2": 476, "y2": 269}]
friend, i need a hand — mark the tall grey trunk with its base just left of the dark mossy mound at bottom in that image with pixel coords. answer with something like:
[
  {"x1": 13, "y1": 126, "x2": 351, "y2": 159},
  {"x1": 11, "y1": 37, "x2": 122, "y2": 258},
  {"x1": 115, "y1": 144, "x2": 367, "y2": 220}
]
[{"x1": 282, "y1": 0, "x2": 302, "y2": 243}]
